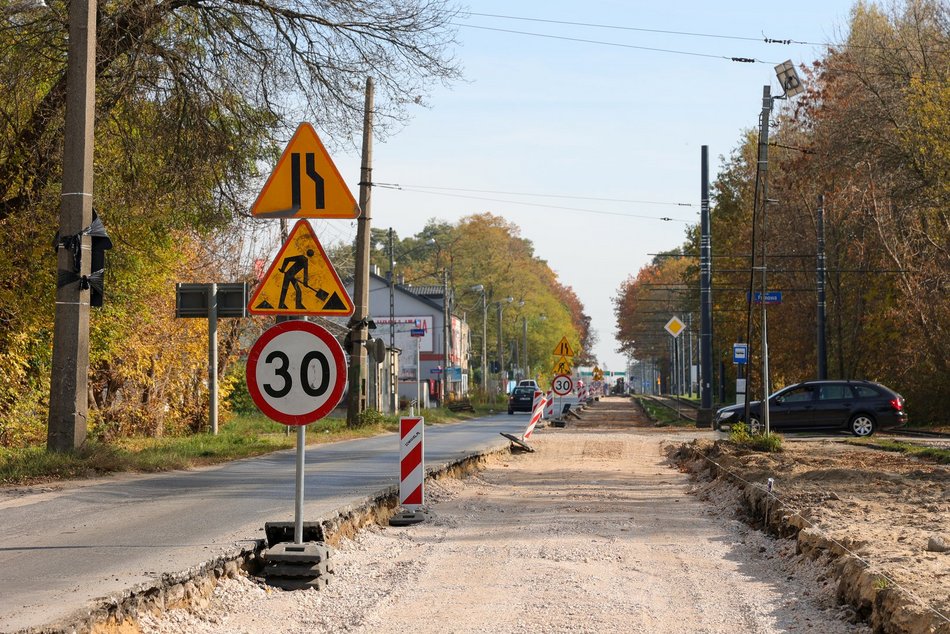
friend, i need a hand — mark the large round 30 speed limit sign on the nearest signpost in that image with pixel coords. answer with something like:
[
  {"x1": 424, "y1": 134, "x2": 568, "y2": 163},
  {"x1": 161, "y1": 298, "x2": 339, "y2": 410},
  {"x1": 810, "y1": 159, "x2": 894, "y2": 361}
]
[{"x1": 247, "y1": 320, "x2": 346, "y2": 425}]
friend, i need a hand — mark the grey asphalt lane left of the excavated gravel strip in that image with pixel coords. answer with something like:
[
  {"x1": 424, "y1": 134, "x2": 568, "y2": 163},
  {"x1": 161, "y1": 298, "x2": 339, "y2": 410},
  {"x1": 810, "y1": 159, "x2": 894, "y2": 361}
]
[{"x1": 0, "y1": 413, "x2": 527, "y2": 632}]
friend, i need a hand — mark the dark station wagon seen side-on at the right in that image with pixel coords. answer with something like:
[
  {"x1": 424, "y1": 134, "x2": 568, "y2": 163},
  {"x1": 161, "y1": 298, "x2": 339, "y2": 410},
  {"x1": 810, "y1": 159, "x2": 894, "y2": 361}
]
[{"x1": 715, "y1": 381, "x2": 907, "y2": 436}]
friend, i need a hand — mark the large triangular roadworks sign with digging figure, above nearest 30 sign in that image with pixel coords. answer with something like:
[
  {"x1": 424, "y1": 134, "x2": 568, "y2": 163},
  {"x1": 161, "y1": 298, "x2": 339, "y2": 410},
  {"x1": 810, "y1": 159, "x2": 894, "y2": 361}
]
[{"x1": 247, "y1": 220, "x2": 353, "y2": 317}]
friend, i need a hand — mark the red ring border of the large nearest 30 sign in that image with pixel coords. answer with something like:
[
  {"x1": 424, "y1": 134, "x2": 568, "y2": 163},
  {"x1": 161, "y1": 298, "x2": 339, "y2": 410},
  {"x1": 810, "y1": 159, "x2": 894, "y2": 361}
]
[{"x1": 245, "y1": 319, "x2": 346, "y2": 426}]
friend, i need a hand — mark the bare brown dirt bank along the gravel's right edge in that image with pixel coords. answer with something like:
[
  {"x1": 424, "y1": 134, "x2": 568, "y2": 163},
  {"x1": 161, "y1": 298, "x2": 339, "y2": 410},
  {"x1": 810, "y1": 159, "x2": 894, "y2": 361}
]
[{"x1": 676, "y1": 434, "x2": 950, "y2": 633}]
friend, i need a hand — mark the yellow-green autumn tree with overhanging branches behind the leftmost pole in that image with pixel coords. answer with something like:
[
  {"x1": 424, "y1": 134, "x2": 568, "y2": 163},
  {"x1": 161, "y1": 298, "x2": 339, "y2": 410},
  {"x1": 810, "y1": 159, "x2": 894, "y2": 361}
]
[{"x1": 0, "y1": 0, "x2": 457, "y2": 444}]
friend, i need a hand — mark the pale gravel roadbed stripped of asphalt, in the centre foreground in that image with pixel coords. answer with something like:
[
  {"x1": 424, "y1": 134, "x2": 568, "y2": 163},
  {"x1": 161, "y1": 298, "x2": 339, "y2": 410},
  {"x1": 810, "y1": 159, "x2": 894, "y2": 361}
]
[{"x1": 139, "y1": 429, "x2": 869, "y2": 634}]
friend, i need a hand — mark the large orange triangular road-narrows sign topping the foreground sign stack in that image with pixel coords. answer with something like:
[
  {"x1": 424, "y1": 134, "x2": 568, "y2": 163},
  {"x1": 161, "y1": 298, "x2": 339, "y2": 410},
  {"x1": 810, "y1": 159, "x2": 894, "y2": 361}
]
[{"x1": 251, "y1": 123, "x2": 360, "y2": 218}]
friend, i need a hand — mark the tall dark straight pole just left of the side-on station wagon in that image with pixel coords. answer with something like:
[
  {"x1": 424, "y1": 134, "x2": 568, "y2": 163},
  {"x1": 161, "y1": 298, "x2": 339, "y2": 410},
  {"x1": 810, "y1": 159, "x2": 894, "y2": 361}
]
[{"x1": 696, "y1": 145, "x2": 713, "y2": 427}]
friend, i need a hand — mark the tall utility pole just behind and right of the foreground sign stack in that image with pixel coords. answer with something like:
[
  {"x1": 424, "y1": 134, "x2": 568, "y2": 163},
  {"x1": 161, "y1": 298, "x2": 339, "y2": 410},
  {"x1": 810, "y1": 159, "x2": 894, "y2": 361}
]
[{"x1": 346, "y1": 77, "x2": 373, "y2": 427}]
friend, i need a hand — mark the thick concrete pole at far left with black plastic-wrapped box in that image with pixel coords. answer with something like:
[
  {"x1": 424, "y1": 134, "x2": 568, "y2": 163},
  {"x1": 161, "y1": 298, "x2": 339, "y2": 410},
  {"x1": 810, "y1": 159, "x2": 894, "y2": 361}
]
[{"x1": 46, "y1": 0, "x2": 96, "y2": 451}]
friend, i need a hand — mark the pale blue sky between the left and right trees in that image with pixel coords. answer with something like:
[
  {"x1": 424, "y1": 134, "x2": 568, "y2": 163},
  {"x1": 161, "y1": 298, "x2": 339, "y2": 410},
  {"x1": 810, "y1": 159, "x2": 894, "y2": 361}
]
[{"x1": 326, "y1": 0, "x2": 852, "y2": 370}]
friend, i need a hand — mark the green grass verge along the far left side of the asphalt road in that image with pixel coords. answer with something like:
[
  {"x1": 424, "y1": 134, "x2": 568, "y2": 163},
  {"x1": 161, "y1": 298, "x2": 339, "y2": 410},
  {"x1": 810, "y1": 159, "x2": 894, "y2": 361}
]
[{"x1": 0, "y1": 405, "x2": 480, "y2": 485}]
